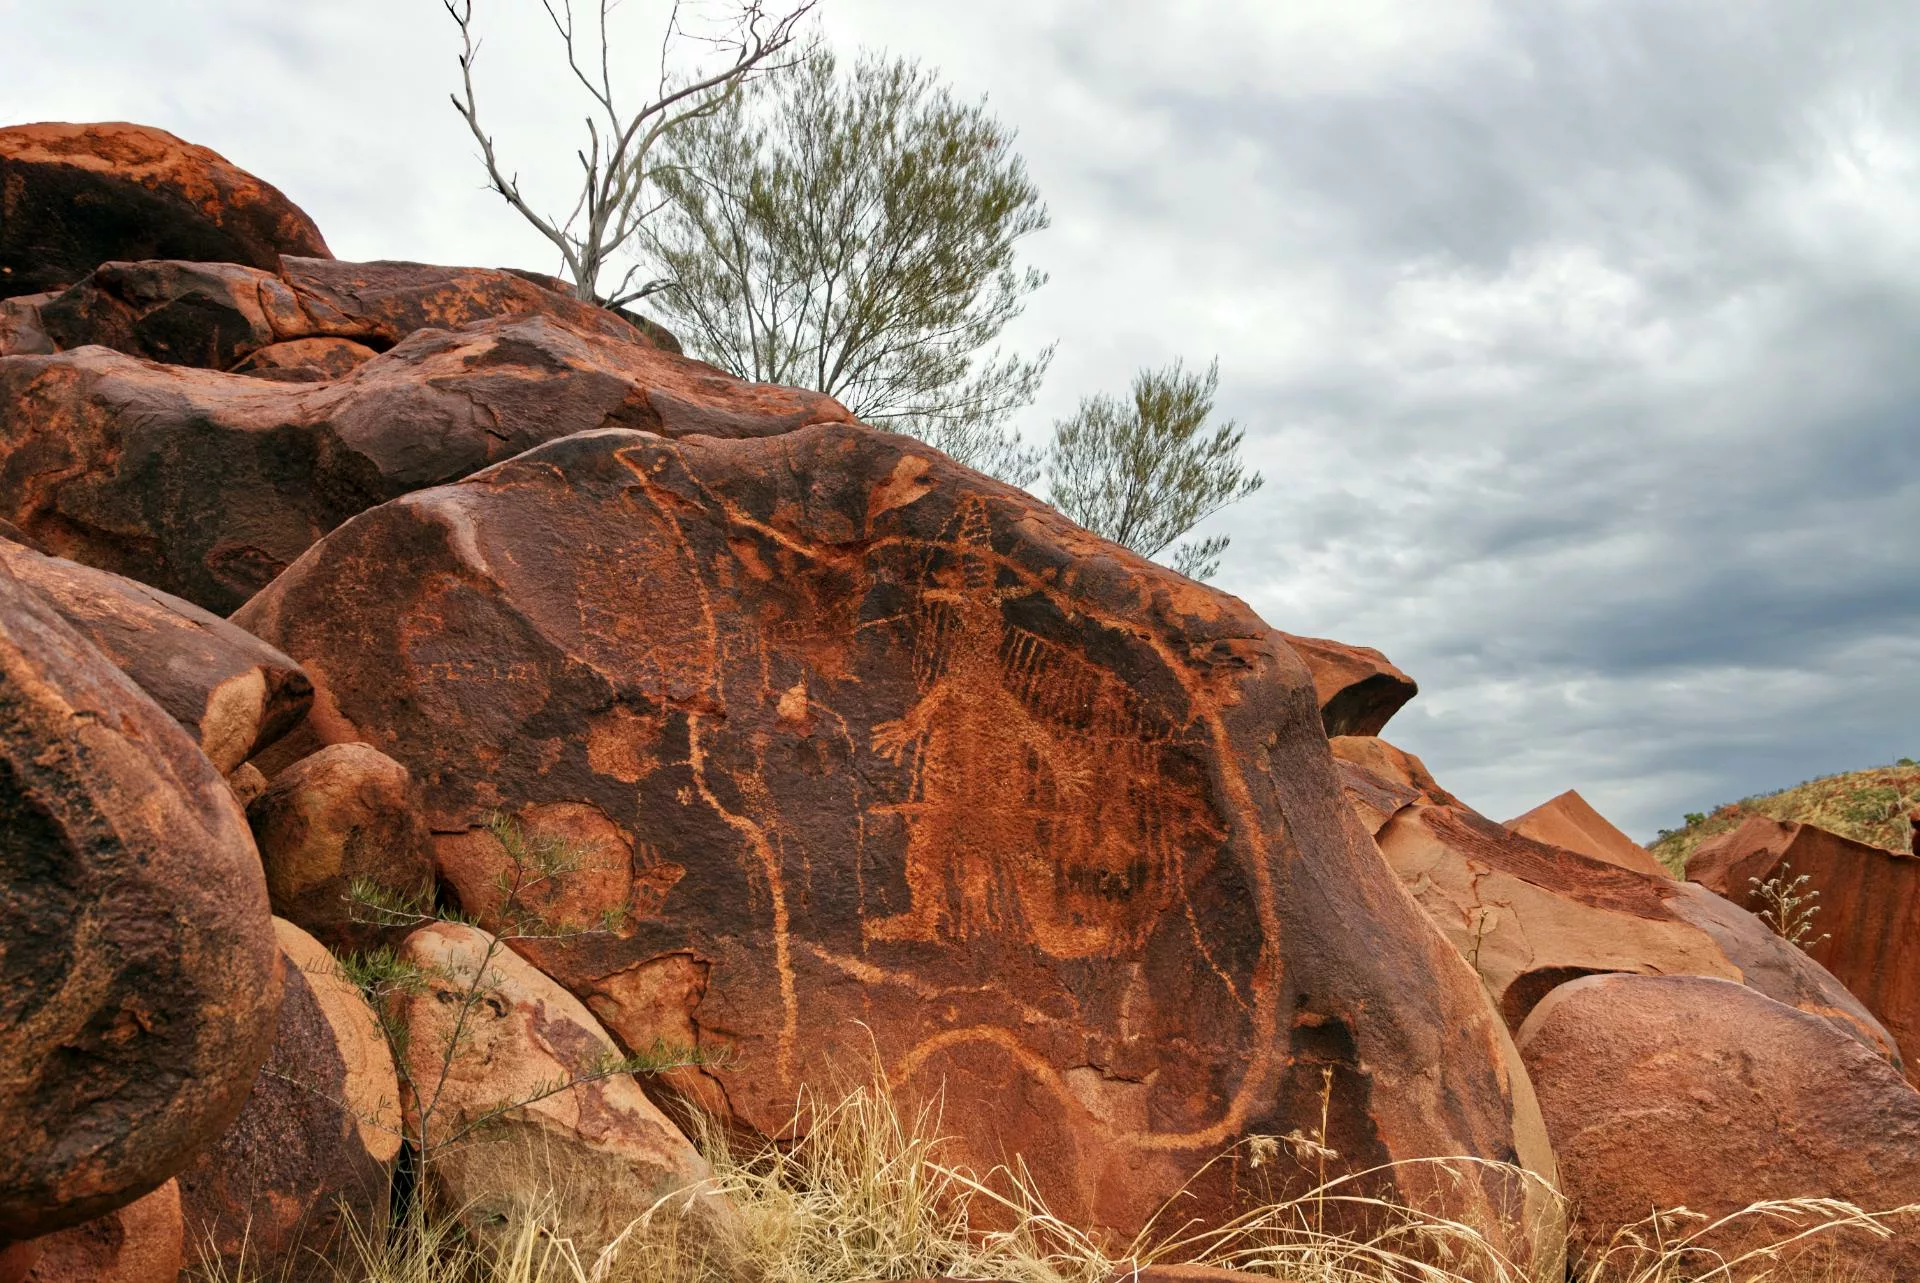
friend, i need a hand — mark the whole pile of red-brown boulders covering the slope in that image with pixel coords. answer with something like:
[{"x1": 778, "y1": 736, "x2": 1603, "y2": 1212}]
[{"x1": 0, "y1": 125, "x2": 1920, "y2": 1279}]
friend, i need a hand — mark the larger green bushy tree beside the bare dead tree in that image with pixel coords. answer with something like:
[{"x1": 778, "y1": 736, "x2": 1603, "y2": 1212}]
[{"x1": 643, "y1": 50, "x2": 1052, "y2": 484}]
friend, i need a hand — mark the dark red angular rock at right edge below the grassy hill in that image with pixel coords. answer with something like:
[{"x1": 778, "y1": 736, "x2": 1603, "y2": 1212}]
[{"x1": 1686, "y1": 816, "x2": 1920, "y2": 1074}]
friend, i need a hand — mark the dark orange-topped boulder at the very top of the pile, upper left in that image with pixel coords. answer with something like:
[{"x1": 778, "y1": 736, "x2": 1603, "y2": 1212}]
[{"x1": 0, "y1": 123, "x2": 326, "y2": 296}]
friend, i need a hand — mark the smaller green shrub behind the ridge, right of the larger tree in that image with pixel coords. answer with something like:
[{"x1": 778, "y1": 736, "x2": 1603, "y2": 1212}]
[{"x1": 1046, "y1": 361, "x2": 1263, "y2": 580}]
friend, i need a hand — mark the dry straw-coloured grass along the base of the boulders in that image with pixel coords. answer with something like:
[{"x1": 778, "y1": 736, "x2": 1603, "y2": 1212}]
[{"x1": 204, "y1": 1085, "x2": 1920, "y2": 1283}]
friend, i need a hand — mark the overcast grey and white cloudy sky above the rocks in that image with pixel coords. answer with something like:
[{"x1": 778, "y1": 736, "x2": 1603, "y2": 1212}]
[{"x1": 0, "y1": 0, "x2": 1920, "y2": 839}]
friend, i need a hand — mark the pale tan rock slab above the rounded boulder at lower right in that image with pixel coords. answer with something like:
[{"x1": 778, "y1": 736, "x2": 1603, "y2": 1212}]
[{"x1": 1379, "y1": 803, "x2": 1899, "y2": 1060}]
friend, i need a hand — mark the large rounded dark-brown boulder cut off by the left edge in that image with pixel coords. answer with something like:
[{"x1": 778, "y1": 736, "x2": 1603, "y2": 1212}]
[{"x1": 0, "y1": 569, "x2": 280, "y2": 1239}]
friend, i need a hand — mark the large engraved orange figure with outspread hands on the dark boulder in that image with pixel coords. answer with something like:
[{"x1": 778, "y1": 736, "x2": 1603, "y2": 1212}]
[{"x1": 866, "y1": 496, "x2": 1217, "y2": 958}]
